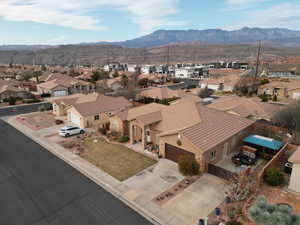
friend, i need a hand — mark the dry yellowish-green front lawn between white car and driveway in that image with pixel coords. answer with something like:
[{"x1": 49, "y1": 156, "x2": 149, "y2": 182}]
[{"x1": 82, "y1": 138, "x2": 156, "y2": 181}]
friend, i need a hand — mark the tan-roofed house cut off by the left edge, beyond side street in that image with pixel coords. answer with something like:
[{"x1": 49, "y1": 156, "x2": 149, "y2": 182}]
[{"x1": 0, "y1": 80, "x2": 31, "y2": 100}]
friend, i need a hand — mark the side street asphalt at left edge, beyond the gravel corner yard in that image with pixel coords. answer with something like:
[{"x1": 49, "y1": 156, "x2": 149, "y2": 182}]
[{"x1": 0, "y1": 103, "x2": 47, "y2": 117}]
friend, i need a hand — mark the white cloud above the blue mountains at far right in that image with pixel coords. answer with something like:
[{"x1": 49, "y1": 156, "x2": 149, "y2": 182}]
[{"x1": 225, "y1": 3, "x2": 300, "y2": 30}]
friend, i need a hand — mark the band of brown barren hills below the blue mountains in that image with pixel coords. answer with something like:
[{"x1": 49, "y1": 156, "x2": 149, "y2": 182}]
[{"x1": 0, "y1": 43, "x2": 300, "y2": 65}]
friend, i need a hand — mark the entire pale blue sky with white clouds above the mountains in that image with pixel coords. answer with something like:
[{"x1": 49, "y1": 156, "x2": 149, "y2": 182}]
[{"x1": 0, "y1": 0, "x2": 300, "y2": 45}]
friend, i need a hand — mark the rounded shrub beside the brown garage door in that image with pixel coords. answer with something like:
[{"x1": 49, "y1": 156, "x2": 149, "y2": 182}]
[{"x1": 178, "y1": 155, "x2": 200, "y2": 176}]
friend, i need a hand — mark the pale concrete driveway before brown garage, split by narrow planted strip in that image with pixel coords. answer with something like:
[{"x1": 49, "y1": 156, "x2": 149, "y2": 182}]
[{"x1": 119, "y1": 159, "x2": 226, "y2": 225}]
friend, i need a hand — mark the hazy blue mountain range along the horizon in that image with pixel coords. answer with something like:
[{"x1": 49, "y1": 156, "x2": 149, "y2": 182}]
[{"x1": 0, "y1": 27, "x2": 300, "y2": 51}]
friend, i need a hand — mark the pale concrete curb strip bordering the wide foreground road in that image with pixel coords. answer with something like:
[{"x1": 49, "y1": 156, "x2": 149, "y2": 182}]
[{"x1": 4, "y1": 118, "x2": 166, "y2": 225}]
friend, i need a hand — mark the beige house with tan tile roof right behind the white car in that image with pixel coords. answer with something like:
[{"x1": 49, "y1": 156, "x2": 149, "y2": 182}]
[{"x1": 53, "y1": 93, "x2": 132, "y2": 128}]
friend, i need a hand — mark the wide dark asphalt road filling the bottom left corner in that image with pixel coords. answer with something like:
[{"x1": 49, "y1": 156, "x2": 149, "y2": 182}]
[{"x1": 0, "y1": 120, "x2": 151, "y2": 225}]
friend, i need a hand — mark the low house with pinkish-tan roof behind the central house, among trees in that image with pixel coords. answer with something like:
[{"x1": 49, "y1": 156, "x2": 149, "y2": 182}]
[{"x1": 139, "y1": 87, "x2": 186, "y2": 100}]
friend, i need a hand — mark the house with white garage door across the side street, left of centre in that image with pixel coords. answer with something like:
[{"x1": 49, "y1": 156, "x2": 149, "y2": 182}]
[{"x1": 37, "y1": 74, "x2": 95, "y2": 97}]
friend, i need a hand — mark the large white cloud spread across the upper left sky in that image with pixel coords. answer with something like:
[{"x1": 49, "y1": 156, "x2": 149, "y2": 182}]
[{"x1": 0, "y1": 0, "x2": 182, "y2": 31}]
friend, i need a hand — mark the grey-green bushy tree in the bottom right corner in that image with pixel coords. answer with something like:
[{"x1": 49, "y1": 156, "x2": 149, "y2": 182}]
[{"x1": 248, "y1": 196, "x2": 300, "y2": 225}]
